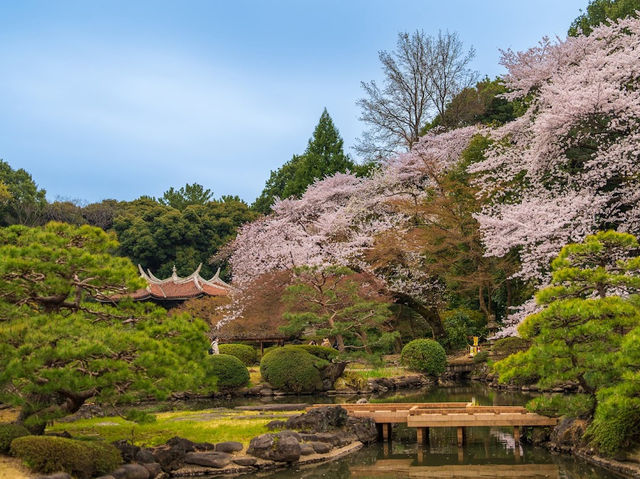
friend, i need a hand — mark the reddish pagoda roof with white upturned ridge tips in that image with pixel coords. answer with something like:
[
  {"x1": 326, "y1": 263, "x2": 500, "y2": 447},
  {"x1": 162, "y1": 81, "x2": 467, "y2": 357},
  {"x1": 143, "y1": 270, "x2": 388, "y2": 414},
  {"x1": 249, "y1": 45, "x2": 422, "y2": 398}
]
[{"x1": 122, "y1": 263, "x2": 233, "y2": 301}]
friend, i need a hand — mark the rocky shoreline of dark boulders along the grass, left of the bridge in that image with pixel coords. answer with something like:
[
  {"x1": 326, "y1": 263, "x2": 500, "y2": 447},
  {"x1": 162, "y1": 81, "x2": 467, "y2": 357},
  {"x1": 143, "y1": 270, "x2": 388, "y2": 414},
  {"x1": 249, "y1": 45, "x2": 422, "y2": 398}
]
[{"x1": 35, "y1": 406, "x2": 378, "y2": 479}]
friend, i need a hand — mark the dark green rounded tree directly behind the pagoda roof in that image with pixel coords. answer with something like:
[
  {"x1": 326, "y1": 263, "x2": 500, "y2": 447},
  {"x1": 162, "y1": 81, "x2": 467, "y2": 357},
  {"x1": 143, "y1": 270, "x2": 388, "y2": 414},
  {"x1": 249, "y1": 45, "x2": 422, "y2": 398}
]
[{"x1": 113, "y1": 194, "x2": 256, "y2": 278}]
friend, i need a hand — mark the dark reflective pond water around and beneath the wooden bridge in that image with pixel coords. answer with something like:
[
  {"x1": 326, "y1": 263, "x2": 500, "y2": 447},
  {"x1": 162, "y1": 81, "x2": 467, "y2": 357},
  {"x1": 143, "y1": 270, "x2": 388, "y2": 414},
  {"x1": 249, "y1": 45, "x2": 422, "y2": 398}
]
[{"x1": 166, "y1": 383, "x2": 619, "y2": 479}]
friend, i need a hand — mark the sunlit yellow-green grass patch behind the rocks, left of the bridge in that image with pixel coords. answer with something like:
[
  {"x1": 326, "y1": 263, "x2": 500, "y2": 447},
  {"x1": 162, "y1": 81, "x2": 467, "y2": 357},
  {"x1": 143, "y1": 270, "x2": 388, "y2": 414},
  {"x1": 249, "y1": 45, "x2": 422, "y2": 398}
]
[{"x1": 47, "y1": 409, "x2": 299, "y2": 447}]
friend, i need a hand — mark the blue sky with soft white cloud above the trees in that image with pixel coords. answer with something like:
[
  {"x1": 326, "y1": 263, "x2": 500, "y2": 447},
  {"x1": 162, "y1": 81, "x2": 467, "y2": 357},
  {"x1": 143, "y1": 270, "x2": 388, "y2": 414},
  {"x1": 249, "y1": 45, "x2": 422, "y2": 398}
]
[{"x1": 0, "y1": 0, "x2": 587, "y2": 202}]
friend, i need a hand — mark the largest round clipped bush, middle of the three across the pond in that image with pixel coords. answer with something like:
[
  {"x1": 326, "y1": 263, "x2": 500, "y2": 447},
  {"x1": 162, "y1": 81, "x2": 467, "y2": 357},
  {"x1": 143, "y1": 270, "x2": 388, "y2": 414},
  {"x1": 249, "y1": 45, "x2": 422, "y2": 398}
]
[{"x1": 260, "y1": 346, "x2": 329, "y2": 393}]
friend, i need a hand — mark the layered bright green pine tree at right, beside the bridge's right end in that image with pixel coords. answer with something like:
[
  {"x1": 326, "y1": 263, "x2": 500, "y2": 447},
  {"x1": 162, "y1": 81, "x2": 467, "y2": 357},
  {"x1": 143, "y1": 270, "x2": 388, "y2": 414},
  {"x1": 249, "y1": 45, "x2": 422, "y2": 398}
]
[{"x1": 495, "y1": 231, "x2": 640, "y2": 395}]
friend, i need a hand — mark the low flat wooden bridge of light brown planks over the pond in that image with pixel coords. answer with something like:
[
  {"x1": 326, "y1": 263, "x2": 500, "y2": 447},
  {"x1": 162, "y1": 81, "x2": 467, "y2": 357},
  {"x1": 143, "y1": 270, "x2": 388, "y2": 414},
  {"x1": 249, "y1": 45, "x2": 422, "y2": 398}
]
[{"x1": 312, "y1": 402, "x2": 558, "y2": 446}]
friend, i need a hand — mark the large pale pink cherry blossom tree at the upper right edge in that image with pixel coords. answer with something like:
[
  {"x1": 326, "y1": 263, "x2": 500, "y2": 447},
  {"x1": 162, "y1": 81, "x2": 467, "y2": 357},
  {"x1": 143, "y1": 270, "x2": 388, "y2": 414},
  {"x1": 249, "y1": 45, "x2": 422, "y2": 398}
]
[{"x1": 469, "y1": 18, "x2": 640, "y2": 334}]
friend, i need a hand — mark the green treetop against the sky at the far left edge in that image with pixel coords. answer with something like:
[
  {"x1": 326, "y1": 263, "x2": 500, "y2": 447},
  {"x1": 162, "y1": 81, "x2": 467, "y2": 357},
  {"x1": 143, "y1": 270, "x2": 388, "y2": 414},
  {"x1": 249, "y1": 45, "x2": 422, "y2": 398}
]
[{"x1": 0, "y1": 160, "x2": 47, "y2": 226}]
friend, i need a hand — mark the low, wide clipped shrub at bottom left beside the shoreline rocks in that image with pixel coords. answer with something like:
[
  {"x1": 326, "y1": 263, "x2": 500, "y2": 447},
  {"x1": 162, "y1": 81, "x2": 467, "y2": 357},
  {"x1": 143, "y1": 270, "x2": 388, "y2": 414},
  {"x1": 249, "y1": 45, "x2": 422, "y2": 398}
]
[{"x1": 11, "y1": 436, "x2": 122, "y2": 479}]
